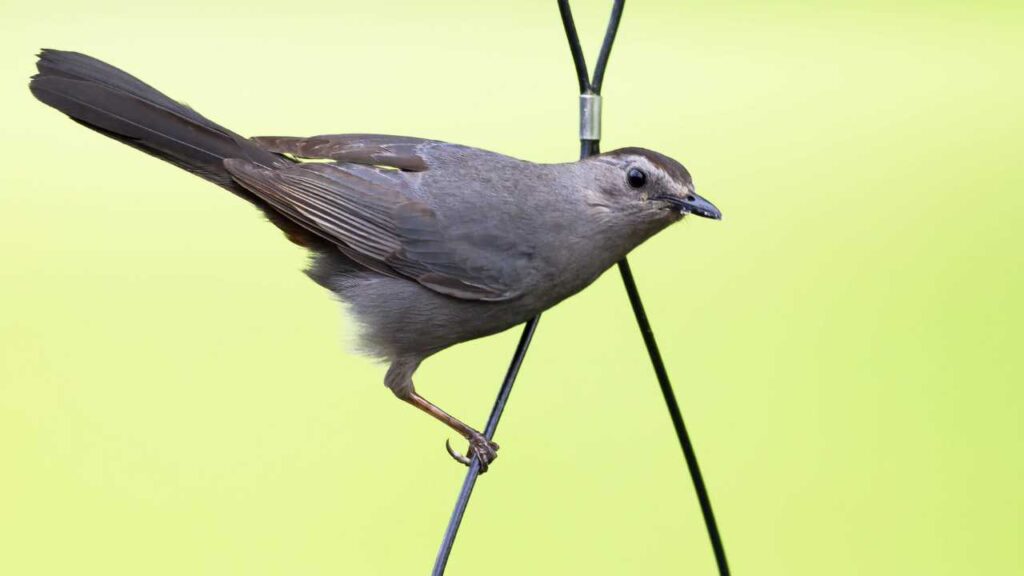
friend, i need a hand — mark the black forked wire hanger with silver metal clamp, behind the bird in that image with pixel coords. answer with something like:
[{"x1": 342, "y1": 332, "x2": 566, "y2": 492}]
[{"x1": 431, "y1": 0, "x2": 729, "y2": 576}]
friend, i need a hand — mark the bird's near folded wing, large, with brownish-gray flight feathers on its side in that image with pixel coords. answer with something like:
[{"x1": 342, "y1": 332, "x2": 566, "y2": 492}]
[{"x1": 224, "y1": 154, "x2": 519, "y2": 301}]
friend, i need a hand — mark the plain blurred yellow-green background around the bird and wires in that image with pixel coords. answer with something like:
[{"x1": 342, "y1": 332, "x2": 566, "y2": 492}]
[{"x1": 0, "y1": 0, "x2": 1024, "y2": 575}]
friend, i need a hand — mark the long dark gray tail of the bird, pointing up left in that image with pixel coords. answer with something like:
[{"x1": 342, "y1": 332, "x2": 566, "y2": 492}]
[{"x1": 29, "y1": 49, "x2": 308, "y2": 244}]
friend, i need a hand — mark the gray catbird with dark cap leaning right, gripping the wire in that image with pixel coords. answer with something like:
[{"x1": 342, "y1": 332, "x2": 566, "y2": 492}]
[{"x1": 30, "y1": 50, "x2": 721, "y2": 470}]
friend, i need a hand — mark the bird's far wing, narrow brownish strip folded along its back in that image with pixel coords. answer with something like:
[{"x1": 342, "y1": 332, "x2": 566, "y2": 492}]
[{"x1": 252, "y1": 134, "x2": 440, "y2": 172}]
